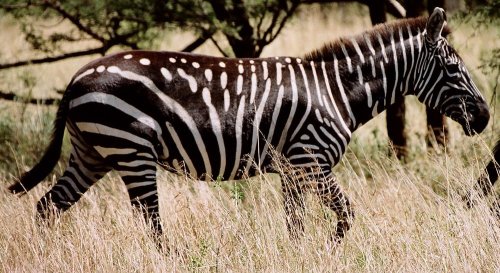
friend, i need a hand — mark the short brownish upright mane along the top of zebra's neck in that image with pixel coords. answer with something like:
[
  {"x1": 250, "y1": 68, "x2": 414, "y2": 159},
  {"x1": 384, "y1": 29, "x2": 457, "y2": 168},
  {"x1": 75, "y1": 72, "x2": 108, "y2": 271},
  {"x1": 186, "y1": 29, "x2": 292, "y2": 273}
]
[{"x1": 304, "y1": 17, "x2": 451, "y2": 61}]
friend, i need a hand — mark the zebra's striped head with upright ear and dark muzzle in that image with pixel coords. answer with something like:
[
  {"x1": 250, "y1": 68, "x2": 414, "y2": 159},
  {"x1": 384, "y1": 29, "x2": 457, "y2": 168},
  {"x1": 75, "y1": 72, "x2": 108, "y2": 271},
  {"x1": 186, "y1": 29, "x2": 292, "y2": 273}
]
[{"x1": 415, "y1": 8, "x2": 490, "y2": 135}]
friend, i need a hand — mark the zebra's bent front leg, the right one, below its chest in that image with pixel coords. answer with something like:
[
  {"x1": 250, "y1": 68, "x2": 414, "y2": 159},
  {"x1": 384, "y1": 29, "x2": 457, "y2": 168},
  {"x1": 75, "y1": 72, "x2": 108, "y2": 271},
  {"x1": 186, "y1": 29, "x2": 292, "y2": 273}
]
[{"x1": 315, "y1": 174, "x2": 354, "y2": 243}]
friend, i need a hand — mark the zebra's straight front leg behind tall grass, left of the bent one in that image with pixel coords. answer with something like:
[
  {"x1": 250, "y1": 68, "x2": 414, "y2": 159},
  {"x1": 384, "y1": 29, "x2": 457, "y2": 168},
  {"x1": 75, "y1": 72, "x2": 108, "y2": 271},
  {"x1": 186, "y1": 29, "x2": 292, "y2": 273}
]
[{"x1": 281, "y1": 175, "x2": 304, "y2": 240}]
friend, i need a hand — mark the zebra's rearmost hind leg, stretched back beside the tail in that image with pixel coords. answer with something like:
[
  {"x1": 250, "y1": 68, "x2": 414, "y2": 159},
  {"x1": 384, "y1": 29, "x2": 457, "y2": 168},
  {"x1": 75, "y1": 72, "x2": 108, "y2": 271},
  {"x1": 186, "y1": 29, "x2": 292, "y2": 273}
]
[{"x1": 37, "y1": 149, "x2": 111, "y2": 221}]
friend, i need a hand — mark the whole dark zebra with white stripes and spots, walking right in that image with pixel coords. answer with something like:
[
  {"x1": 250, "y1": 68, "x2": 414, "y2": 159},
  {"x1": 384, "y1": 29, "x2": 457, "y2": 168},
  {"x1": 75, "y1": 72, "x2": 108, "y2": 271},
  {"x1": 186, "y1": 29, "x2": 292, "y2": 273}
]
[{"x1": 9, "y1": 8, "x2": 489, "y2": 240}]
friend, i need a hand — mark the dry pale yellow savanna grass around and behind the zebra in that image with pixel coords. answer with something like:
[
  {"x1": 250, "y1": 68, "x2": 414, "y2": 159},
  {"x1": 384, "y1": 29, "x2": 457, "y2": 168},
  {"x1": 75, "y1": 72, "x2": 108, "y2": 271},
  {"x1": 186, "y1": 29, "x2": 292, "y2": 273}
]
[{"x1": 0, "y1": 6, "x2": 500, "y2": 272}]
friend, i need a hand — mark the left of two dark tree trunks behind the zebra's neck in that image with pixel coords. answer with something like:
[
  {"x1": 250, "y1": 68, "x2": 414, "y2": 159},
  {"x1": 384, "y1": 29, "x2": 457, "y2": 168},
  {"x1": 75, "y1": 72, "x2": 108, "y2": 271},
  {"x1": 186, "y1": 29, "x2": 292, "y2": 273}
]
[{"x1": 368, "y1": 0, "x2": 408, "y2": 159}]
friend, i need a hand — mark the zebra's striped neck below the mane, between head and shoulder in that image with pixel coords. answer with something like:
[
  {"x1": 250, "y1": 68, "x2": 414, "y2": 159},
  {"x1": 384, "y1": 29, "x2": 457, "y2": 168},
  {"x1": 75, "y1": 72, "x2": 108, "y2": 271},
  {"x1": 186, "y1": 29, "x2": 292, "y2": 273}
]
[{"x1": 321, "y1": 25, "x2": 422, "y2": 132}]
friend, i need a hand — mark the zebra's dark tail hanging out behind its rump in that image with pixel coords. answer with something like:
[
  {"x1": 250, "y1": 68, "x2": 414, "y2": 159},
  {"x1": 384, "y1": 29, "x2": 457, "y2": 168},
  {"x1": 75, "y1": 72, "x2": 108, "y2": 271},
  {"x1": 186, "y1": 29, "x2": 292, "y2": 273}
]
[{"x1": 9, "y1": 84, "x2": 71, "y2": 195}]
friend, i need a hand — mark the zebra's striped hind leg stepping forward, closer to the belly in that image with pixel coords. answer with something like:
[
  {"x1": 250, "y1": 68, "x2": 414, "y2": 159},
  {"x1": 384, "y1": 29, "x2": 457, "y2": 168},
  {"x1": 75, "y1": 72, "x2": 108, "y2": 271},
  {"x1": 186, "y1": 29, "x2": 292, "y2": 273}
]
[{"x1": 118, "y1": 160, "x2": 163, "y2": 237}]
